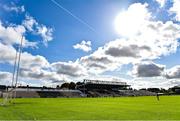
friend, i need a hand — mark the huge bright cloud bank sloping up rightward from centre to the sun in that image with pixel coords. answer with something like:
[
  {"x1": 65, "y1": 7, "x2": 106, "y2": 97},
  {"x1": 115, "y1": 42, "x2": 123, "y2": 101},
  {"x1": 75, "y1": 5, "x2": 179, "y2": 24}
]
[{"x1": 79, "y1": 3, "x2": 180, "y2": 73}]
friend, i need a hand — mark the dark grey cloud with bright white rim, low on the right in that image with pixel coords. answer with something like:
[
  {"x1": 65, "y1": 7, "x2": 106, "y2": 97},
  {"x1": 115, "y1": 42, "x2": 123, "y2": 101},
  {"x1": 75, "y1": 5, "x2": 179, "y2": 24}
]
[{"x1": 132, "y1": 62, "x2": 165, "y2": 77}]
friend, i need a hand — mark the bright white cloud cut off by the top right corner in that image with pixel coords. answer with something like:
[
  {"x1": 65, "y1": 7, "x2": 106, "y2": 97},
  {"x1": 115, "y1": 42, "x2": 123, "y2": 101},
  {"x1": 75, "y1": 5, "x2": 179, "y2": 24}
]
[{"x1": 169, "y1": 0, "x2": 180, "y2": 21}]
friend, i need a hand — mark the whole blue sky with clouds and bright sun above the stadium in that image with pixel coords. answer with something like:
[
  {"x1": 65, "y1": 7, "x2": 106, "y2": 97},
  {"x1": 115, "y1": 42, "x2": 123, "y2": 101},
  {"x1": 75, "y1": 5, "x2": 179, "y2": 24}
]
[{"x1": 0, "y1": 0, "x2": 180, "y2": 89}]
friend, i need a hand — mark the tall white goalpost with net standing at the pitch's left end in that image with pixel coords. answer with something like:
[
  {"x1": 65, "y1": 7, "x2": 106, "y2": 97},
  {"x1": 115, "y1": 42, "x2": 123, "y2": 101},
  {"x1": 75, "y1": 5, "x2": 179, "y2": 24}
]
[{"x1": 1, "y1": 35, "x2": 23, "y2": 105}]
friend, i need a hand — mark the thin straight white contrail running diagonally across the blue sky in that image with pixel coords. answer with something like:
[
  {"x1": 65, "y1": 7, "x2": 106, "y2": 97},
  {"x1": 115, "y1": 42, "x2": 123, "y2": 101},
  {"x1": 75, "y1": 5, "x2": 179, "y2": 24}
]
[{"x1": 51, "y1": 0, "x2": 96, "y2": 33}]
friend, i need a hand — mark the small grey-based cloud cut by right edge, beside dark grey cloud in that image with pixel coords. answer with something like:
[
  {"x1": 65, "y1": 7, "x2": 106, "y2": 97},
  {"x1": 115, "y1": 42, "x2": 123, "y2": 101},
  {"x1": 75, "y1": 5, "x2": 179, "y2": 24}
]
[{"x1": 166, "y1": 65, "x2": 180, "y2": 79}]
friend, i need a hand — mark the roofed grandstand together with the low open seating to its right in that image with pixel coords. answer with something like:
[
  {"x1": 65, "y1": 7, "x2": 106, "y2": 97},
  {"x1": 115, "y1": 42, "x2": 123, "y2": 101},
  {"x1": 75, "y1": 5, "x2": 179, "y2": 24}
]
[{"x1": 77, "y1": 79, "x2": 156, "y2": 97}]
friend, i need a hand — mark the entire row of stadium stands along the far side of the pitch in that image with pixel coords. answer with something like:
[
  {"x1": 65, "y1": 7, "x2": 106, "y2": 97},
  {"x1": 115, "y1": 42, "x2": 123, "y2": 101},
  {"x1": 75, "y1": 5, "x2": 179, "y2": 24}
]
[{"x1": 0, "y1": 79, "x2": 160, "y2": 98}]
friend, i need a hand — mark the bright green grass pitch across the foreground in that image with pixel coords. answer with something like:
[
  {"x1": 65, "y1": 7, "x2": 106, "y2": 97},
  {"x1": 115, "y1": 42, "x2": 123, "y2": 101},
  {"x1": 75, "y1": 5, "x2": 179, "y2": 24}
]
[{"x1": 0, "y1": 96, "x2": 180, "y2": 120}]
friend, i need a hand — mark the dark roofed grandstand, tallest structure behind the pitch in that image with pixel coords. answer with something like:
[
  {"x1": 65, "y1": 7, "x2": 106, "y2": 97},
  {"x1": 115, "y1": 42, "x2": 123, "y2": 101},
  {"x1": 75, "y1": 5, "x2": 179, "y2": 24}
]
[{"x1": 76, "y1": 79, "x2": 130, "y2": 97}]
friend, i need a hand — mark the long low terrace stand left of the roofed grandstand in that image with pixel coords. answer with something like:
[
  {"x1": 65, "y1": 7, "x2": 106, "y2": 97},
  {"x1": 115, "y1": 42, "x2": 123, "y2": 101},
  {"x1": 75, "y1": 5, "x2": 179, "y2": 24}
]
[{"x1": 0, "y1": 86, "x2": 85, "y2": 98}]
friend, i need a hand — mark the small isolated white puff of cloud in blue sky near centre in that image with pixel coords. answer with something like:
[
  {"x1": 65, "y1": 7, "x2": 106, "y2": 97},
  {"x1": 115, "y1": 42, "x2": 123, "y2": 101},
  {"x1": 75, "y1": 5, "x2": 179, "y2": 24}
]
[{"x1": 73, "y1": 40, "x2": 92, "y2": 52}]
